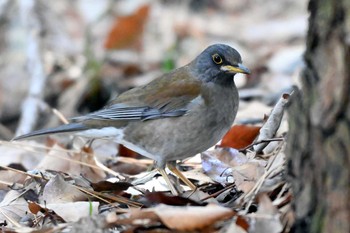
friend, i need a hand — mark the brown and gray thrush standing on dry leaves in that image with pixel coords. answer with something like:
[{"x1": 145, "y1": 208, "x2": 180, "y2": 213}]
[{"x1": 14, "y1": 44, "x2": 250, "y2": 195}]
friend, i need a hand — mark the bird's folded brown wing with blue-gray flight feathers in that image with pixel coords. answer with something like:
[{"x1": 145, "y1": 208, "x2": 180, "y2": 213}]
[{"x1": 73, "y1": 68, "x2": 201, "y2": 122}]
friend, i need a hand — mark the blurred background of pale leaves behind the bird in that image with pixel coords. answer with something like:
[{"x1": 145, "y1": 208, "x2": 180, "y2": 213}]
[{"x1": 0, "y1": 0, "x2": 308, "y2": 140}]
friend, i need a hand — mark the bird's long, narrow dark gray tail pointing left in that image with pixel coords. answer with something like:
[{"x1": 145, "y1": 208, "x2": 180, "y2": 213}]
[{"x1": 12, "y1": 123, "x2": 88, "y2": 140}]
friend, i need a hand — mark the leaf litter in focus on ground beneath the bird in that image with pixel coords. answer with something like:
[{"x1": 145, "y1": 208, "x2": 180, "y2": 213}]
[{"x1": 0, "y1": 92, "x2": 291, "y2": 232}]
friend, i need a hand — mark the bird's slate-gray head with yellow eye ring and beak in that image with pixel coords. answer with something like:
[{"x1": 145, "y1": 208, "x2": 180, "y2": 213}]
[{"x1": 190, "y1": 44, "x2": 250, "y2": 85}]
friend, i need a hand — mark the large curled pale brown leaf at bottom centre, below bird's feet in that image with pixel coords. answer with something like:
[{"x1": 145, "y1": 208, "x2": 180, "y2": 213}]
[{"x1": 152, "y1": 204, "x2": 236, "y2": 231}]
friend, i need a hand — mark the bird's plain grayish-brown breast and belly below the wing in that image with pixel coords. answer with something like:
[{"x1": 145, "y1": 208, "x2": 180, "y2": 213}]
[{"x1": 124, "y1": 83, "x2": 238, "y2": 164}]
